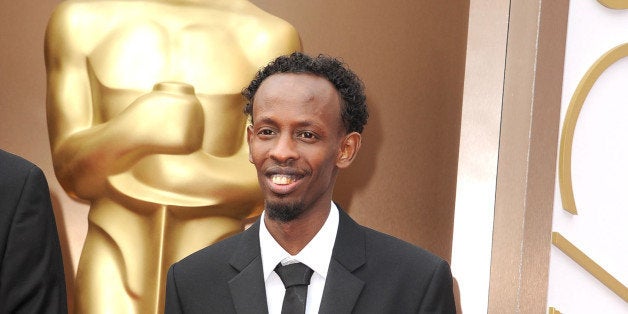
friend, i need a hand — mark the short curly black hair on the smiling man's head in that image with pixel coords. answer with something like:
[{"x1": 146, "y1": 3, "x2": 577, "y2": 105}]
[{"x1": 242, "y1": 52, "x2": 369, "y2": 133}]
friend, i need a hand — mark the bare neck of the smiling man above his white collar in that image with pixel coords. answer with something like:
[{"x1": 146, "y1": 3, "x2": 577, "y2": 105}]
[{"x1": 264, "y1": 203, "x2": 330, "y2": 255}]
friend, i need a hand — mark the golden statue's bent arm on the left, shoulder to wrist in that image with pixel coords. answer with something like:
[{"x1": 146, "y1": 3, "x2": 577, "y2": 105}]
[{"x1": 45, "y1": 3, "x2": 203, "y2": 199}]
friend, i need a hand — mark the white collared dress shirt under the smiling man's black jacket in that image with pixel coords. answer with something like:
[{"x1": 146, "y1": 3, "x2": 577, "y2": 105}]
[{"x1": 259, "y1": 202, "x2": 339, "y2": 314}]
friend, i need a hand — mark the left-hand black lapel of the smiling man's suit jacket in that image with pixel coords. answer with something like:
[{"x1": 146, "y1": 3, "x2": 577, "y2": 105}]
[{"x1": 229, "y1": 220, "x2": 268, "y2": 314}]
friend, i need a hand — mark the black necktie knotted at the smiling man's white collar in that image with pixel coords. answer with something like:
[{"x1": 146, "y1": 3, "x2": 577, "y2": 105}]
[{"x1": 275, "y1": 263, "x2": 314, "y2": 314}]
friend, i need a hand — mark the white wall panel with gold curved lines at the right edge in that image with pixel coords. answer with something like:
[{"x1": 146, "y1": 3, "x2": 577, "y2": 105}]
[{"x1": 547, "y1": 0, "x2": 628, "y2": 313}]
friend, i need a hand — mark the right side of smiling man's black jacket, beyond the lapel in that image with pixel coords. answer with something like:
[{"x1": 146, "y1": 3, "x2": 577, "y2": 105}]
[{"x1": 354, "y1": 227, "x2": 455, "y2": 313}]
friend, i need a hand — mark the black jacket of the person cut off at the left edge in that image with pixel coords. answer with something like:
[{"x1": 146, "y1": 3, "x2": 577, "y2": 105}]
[{"x1": 0, "y1": 150, "x2": 67, "y2": 314}]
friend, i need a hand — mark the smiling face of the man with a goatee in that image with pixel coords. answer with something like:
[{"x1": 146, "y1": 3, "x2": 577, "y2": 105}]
[{"x1": 247, "y1": 73, "x2": 350, "y2": 221}]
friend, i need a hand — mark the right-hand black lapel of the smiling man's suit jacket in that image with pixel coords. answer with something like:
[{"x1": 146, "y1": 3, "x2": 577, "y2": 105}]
[{"x1": 319, "y1": 209, "x2": 366, "y2": 313}]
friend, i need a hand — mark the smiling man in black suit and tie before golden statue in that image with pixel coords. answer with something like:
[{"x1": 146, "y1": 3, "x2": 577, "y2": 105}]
[{"x1": 166, "y1": 53, "x2": 455, "y2": 313}]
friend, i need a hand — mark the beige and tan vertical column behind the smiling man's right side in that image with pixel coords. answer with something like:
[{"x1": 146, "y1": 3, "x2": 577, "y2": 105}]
[{"x1": 452, "y1": 0, "x2": 569, "y2": 313}]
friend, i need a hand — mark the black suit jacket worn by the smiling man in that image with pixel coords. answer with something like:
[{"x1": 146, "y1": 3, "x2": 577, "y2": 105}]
[{"x1": 166, "y1": 210, "x2": 456, "y2": 314}]
